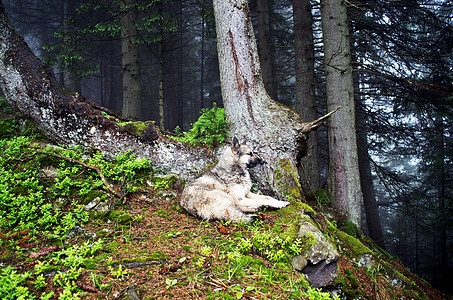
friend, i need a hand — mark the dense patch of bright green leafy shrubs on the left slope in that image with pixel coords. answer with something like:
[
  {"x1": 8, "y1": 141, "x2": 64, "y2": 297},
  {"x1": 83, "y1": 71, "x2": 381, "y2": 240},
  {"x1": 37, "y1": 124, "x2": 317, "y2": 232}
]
[{"x1": 0, "y1": 121, "x2": 151, "y2": 246}]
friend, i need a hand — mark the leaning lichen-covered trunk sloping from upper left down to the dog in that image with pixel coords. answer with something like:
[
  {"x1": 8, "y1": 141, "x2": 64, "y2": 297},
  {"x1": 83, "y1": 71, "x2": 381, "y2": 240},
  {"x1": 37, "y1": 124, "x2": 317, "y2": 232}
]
[{"x1": 0, "y1": 2, "x2": 207, "y2": 179}]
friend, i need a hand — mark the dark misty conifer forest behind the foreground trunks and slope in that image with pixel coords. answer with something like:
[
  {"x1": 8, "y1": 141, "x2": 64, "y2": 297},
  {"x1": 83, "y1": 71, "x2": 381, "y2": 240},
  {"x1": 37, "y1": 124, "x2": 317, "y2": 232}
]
[{"x1": 3, "y1": 0, "x2": 453, "y2": 293}]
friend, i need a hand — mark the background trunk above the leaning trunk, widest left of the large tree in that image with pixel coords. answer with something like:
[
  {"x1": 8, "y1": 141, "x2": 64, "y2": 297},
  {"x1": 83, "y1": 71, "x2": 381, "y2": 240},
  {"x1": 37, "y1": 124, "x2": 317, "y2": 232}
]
[{"x1": 121, "y1": 0, "x2": 141, "y2": 119}]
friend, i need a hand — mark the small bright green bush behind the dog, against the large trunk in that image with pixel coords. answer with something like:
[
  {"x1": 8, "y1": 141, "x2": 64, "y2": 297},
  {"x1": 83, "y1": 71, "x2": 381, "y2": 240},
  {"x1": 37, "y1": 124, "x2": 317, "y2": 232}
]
[{"x1": 171, "y1": 103, "x2": 230, "y2": 148}]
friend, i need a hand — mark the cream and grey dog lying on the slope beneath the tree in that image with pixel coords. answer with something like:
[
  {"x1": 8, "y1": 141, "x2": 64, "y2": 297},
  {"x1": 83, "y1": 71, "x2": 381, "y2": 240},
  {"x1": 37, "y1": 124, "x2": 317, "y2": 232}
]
[{"x1": 180, "y1": 138, "x2": 289, "y2": 223}]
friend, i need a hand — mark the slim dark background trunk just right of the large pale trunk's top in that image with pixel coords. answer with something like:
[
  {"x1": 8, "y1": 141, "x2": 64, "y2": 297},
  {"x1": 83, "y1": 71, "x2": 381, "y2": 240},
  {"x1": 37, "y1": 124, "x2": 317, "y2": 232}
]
[{"x1": 256, "y1": 0, "x2": 276, "y2": 99}]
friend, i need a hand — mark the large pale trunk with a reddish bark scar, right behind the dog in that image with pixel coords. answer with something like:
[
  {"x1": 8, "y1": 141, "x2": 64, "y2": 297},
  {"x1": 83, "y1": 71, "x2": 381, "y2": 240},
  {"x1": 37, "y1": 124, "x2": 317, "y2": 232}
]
[{"x1": 214, "y1": 0, "x2": 328, "y2": 201}]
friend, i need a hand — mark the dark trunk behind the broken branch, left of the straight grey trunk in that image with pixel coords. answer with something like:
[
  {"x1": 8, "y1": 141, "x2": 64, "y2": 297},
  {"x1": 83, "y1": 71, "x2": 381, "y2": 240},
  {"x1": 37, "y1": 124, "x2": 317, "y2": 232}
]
[{"x1": 293, "y1": 0, "x2": 319, "y2": 191}]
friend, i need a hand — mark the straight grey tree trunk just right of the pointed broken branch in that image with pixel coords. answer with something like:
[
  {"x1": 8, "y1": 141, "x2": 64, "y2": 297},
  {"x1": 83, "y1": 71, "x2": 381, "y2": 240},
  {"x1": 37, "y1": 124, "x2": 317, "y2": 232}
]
[{"x1": 321, "y1": 0, "x2": 362, "y2": 227}]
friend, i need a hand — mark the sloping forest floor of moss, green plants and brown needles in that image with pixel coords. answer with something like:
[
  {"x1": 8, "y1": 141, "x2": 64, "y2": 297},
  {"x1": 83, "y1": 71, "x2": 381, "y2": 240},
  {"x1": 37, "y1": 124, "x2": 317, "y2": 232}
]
[{"x1": 0, "y1": 106, "x2": 445, "y2": 300}]
